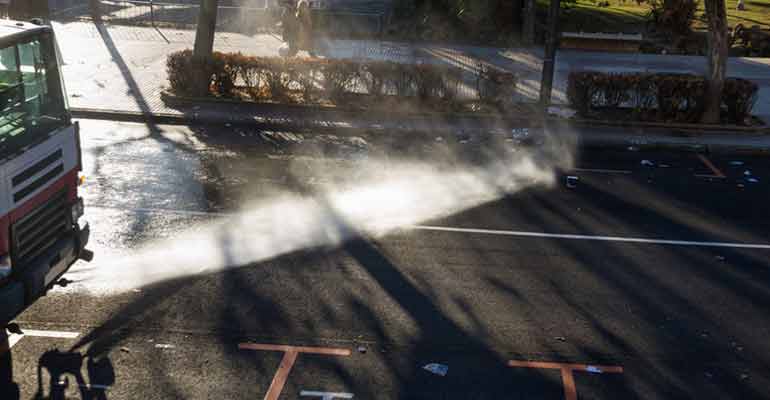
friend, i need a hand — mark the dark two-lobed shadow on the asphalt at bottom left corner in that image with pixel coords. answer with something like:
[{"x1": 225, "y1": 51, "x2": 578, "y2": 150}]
[{"x1": 34, "y1": 349, "x2": 115, "y2": 400}]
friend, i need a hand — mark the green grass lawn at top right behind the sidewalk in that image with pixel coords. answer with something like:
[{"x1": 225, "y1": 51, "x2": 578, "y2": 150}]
[{"x1": 537, "y1": 0, "x2": 770, "y2": 33}]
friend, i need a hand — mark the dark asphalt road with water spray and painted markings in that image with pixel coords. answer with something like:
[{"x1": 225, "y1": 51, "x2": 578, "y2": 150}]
[{"x1": 0, "y1": 121, "x2": 770, "y2": 400}]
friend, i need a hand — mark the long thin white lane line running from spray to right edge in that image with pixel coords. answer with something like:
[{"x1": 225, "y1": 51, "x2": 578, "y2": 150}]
[{"x1": 412, "y1": 225, "x2": 770, "y2": 250}]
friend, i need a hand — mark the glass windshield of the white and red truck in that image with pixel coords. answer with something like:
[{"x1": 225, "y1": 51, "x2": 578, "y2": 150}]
[{"x1": 0, "y1": 33, "x2": 69, "y2": 158}]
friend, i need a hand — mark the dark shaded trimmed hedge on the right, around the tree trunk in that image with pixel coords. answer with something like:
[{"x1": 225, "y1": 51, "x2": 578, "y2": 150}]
[{"x1": 567, "y1": 71, "x2": 759, "y2": 124}]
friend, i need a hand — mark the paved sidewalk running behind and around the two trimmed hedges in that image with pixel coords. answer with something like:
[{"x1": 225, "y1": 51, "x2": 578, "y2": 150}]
[{"x1": 54, "y1": 22, "x2": 770, "y2": 153}]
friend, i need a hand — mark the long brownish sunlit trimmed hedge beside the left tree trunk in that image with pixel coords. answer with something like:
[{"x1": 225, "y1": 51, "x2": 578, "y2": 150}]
[{"x1": 166, "y1": 50, "x2": 516, "y2": 106}]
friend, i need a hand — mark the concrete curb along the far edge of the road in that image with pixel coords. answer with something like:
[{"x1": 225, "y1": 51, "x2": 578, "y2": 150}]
[{"x1": 72, "y1": 108, "x2": 770, "y2": 155}]
